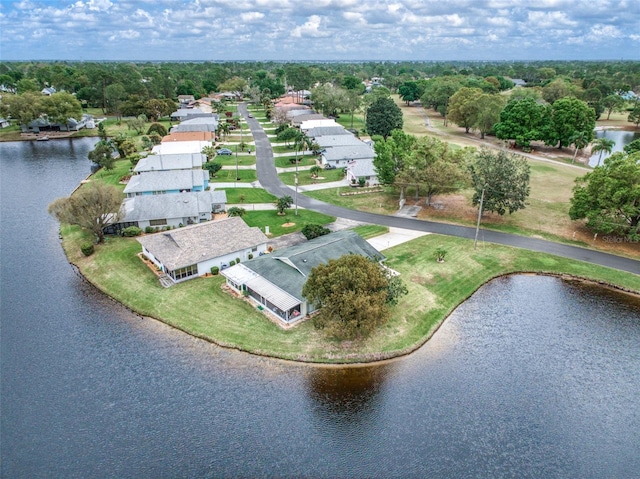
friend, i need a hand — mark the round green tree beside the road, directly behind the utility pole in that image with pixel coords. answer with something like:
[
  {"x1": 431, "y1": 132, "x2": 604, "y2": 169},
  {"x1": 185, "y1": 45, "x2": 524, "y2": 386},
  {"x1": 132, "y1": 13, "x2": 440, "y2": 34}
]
[{"x1": 470, "y1": 148, "x2": 530, "y2": 215}]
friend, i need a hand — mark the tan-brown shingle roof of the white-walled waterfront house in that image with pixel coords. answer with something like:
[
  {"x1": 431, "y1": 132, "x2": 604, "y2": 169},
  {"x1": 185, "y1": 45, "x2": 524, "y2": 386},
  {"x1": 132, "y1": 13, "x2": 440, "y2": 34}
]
[{"x1": 137, "y1": 216, "x2": 268, "y2": 270}]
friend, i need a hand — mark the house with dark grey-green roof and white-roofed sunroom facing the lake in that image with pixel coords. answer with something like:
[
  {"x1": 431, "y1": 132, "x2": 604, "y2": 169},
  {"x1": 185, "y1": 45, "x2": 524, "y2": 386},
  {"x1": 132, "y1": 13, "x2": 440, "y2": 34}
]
[{"x1": 221, "y1": 230, "x2": 384, "y2": 324}]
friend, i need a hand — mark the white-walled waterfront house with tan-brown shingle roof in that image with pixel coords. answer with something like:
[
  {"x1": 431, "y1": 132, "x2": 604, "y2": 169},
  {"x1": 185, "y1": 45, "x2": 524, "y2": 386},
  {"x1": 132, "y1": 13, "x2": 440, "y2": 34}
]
[{"x1": 137, "y1": 216, "x2": 268, "y2": 283}]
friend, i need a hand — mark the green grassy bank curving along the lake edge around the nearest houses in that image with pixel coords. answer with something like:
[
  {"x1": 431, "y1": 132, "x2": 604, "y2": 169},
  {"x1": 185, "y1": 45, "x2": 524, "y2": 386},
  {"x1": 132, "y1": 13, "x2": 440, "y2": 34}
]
[{"x1": 61, "y1": 226, "x2": 640, "y2": 364}]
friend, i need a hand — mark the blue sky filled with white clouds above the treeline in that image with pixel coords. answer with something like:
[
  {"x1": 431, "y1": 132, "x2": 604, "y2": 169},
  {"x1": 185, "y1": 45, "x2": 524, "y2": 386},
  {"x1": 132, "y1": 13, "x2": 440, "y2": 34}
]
[{"x1": 0, "y1": 0, "x2": 640, "y2": 61}]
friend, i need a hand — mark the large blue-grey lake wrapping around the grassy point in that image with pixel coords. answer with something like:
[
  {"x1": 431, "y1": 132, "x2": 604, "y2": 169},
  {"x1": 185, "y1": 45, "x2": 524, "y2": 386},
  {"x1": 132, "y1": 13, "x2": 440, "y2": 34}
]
[{"x1": 0, "y1": 140, "x2": 640, "y2": 478}]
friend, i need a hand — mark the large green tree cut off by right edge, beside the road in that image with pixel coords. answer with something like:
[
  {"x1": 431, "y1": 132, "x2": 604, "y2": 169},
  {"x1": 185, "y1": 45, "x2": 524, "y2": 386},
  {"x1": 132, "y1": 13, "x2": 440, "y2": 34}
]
[{"x1": 569, "y1": 152, "x2": 640, "y2": 241}]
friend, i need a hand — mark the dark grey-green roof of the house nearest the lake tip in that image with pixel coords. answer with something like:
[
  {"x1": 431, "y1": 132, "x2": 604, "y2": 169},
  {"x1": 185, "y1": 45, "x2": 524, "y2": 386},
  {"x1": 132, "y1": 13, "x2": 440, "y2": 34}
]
[{"x1": 238, "y1": 230, "x2": 384, "y2": 300}]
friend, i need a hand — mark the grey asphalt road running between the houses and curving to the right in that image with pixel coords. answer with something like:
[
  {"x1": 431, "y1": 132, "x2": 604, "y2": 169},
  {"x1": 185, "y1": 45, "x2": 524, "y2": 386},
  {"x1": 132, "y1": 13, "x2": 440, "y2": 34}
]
[{"x1": 238, "y1": 103, "x2": 640, "y2": 275}]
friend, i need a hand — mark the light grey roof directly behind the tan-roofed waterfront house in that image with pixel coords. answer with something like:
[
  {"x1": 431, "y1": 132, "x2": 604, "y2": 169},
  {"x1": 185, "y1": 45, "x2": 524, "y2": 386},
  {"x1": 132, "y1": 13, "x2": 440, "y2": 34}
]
[{"x1": 121, "y1": 191, "x2": 227, "y2": 222}]
